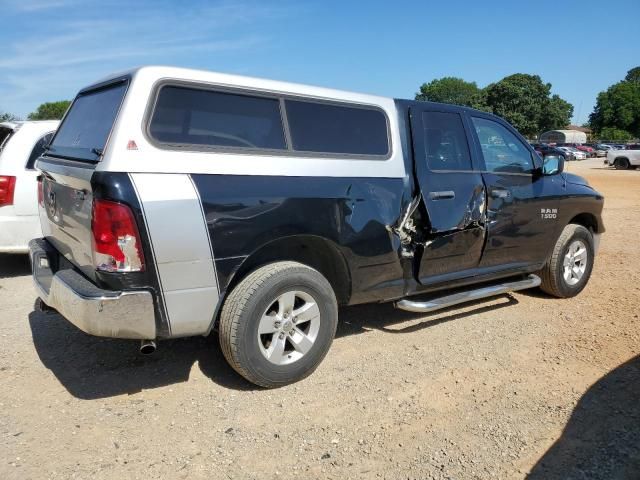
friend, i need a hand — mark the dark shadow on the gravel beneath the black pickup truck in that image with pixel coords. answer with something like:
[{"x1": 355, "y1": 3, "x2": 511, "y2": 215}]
[{"x1": 29, "y1": 295, "x2": 517, "y2": 399}]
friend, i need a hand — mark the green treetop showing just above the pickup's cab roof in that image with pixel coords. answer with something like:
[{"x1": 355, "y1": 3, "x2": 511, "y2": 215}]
[{"x1": 416, "y1": 77, "x2": 487, "y2": 110}]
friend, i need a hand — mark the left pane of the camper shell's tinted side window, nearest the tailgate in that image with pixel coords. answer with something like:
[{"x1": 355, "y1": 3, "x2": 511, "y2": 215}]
[{"x1": 149, "y1": 86, "x2": 287, "y2": 150}]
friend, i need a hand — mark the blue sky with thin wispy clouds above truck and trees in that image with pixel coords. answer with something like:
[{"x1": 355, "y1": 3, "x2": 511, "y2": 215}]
[{"x1": 0, "y1": 0, "x2": 640, "y2": 123}]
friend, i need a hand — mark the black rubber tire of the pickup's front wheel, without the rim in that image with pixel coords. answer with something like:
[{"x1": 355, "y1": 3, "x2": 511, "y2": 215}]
[{"x1": 538, "y1": 223, "x2": 594, "y2": 298}]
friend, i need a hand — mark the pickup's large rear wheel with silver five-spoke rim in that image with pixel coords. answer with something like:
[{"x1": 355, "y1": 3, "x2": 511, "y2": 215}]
[{"x1": 219, "y1": 262, "x2": 338, "y2": 388}]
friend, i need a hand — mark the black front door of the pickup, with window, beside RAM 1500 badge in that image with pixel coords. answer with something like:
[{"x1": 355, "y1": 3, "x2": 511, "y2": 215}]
[{"x1": 470, "y1": 115, "x2": 558, "y2": 268}]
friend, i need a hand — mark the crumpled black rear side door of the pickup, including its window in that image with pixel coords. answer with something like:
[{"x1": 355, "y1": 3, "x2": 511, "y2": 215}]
[{"x1": 410, "y1": 104, "x2": 486, "y2": 284}]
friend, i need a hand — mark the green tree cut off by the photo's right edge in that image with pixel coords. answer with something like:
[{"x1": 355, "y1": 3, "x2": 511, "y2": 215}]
[{"x1": 589, "y1": 67, "x2": 640, "y2": 137}]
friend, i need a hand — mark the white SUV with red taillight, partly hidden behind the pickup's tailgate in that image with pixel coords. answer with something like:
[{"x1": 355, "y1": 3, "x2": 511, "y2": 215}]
[{"x1": 0, "y1": 120, "x2": 60, "y2": 253}]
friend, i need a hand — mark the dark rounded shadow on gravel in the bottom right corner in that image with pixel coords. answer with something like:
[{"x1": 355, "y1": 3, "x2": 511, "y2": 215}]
[{"x1": 528, "y1": 356, "x2": 640, "y2": 480}]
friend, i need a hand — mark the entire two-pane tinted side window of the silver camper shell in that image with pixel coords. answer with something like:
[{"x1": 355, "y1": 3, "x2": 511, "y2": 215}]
[{"x1": 147, "y1": 83, "x2": 391, "y2": 160}]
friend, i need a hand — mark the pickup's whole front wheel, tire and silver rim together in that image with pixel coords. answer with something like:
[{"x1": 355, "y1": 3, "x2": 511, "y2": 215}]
[{"x1": 539, "y1": 224, "x2": 594, "y2": 298}]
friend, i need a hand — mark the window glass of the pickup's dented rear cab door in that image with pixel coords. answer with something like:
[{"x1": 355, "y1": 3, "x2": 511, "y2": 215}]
[{"x1": 422, "y1": 112, "x2": 472, "y2": 170}]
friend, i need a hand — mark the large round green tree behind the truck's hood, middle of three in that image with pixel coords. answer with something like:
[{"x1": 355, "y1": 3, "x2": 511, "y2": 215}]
[{"x1": 486, "y1": 73, "x2": 573, "y2": 137}]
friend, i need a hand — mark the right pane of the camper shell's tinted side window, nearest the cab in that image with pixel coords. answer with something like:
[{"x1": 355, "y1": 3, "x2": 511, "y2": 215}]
[{"x1": 285, "y1": 100, "x2": 389, "y2": 156}]
